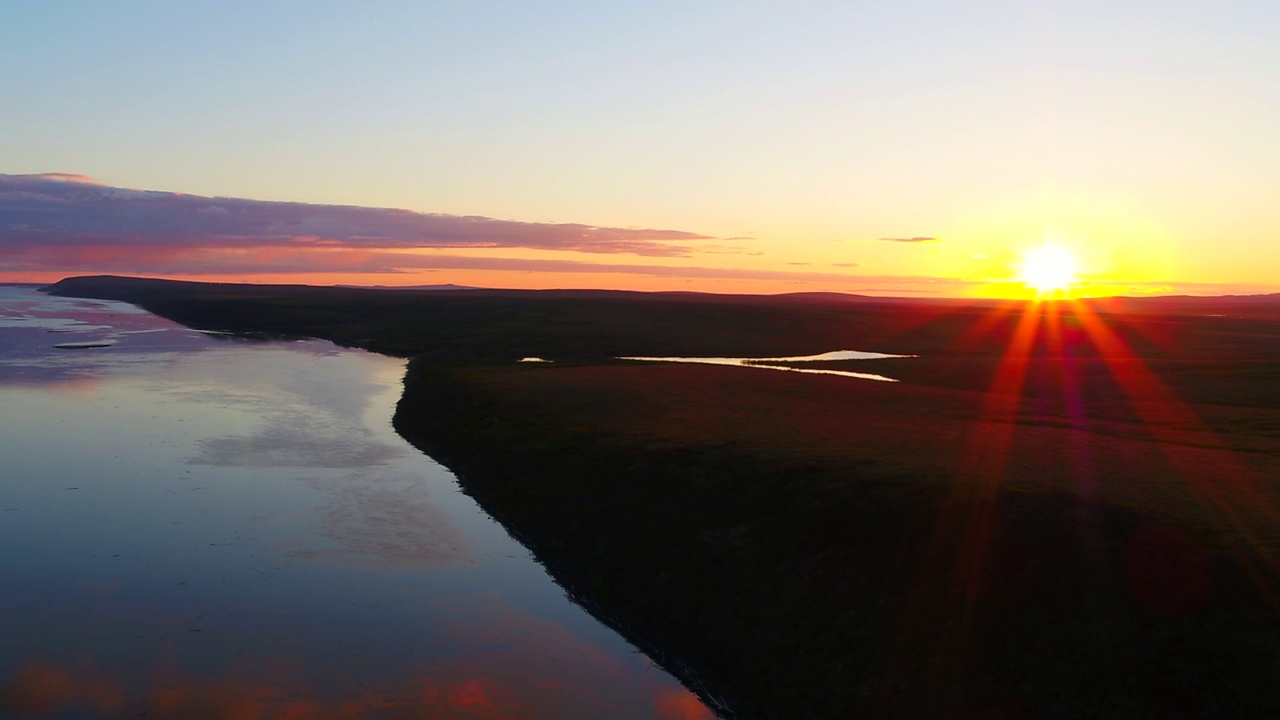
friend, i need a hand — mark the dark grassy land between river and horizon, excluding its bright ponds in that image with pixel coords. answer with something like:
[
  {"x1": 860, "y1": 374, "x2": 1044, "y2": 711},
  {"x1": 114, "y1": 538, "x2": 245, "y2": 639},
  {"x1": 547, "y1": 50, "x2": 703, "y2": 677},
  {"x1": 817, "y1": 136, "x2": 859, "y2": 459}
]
[{"x1": 42, "y1": 278, "x2": 1280, "y2": 719}]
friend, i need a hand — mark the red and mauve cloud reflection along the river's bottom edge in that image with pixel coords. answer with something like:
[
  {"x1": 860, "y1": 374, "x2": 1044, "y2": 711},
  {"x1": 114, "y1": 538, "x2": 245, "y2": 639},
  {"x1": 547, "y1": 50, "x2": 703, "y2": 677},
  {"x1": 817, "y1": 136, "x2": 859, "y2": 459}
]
[{"x1": 0, "y1": 594, "x2": 713, "y2": 720}]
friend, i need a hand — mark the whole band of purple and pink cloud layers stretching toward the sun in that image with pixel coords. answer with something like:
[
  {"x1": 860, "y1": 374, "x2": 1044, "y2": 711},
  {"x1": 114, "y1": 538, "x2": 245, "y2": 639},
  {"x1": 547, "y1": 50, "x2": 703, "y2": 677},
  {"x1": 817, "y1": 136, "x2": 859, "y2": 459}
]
[{"x1": 0, "y1": 173, "x2": 988, "y2": 292}]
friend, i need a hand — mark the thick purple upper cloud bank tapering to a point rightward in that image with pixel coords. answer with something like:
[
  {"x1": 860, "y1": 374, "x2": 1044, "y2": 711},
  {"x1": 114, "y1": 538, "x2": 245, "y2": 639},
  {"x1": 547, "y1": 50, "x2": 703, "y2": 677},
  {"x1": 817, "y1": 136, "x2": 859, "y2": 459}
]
[{"x1": 0, "y1": 173, "x2": 712, "y2": 258}]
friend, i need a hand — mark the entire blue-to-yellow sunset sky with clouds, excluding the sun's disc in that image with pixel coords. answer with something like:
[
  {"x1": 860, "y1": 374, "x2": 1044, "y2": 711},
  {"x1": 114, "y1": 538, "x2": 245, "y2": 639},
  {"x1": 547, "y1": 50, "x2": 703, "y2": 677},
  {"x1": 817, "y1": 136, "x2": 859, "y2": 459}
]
[{"x1": 0, "y1": 0, "x2": 1280, "y2": 296}]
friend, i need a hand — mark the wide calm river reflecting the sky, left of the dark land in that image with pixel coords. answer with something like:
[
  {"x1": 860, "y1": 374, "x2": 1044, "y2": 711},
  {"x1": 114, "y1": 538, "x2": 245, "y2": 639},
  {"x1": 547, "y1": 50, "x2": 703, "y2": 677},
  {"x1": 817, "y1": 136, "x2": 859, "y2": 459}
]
[{"x1": 0, "y1": 286, "x2": 712, "y2": 720}]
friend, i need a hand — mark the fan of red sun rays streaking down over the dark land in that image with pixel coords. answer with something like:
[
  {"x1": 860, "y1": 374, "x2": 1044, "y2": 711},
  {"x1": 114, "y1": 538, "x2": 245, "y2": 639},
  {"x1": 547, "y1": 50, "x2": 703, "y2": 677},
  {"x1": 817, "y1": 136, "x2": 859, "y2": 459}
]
[{"x1": 887, "y1": 293, "x2": 1280, "y2": 697}]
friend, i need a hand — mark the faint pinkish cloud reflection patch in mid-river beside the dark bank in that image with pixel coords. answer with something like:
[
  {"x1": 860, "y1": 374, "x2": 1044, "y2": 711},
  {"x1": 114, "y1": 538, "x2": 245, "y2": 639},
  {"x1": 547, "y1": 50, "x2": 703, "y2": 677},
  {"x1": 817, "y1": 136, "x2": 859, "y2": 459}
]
[{"x1": 291, "y1": 473, "x2": 471, "y2": 571}]
